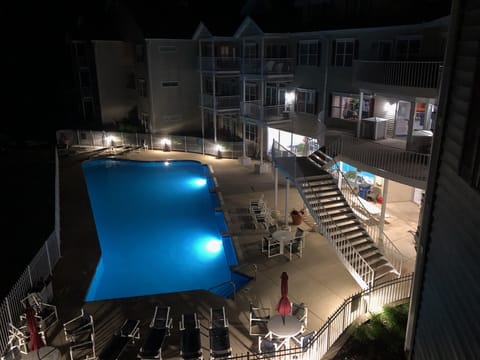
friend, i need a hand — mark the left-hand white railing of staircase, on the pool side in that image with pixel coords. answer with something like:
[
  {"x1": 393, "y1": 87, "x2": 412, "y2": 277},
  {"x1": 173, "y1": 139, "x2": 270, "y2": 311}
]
[{"x1": 272, "y1": 140, "x2": 375, "y2": 289}]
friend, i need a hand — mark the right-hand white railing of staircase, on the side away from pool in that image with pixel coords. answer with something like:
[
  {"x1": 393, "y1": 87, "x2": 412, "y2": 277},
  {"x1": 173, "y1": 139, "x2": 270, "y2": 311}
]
[{"x1": 327, "y1": 155, "x2": 403, "y2": 276}]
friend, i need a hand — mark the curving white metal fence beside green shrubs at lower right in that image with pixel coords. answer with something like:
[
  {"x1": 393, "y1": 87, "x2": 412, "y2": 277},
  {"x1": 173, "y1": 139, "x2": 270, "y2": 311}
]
[{"x1": 231, "y1": 274, "x2": 413, "y2": 360}]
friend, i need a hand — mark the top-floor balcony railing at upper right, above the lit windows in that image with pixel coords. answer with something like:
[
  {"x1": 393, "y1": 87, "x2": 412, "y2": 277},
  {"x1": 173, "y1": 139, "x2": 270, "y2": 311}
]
[{"x1": 354, "y1": 60, "x2": 443, "y2": 89}]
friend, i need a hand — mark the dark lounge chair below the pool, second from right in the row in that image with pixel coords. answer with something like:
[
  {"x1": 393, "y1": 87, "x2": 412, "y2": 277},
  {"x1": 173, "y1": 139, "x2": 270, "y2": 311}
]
[{"x1": 180, "y1": 313, "x2": 203, "y2": 360}]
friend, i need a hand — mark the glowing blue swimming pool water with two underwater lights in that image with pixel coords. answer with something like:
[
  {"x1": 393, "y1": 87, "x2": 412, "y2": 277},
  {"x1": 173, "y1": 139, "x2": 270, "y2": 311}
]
[{"x1": 83, "y1": 159, "x2": 248, "y2": 301}]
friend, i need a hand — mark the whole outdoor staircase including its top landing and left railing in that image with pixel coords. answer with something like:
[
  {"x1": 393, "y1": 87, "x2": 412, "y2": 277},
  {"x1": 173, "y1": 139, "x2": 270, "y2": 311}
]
[{"x1": 275, "y1": 157, "x2": 397, "y2": 288}]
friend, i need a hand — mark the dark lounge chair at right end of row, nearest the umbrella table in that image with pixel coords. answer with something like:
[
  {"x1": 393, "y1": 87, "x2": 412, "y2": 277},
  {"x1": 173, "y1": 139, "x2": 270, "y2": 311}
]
[{"x1": 209, "y1": 306, "x2": 232, "y2": 359}]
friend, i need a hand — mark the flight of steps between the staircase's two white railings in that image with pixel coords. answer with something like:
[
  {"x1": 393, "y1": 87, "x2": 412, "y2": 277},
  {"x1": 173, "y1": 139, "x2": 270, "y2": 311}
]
[{"x1": 296, "y1": 169, "x2": 398, "y2": 286}]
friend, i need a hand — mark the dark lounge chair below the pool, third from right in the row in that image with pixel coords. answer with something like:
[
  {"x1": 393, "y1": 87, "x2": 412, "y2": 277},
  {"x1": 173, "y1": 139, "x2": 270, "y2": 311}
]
[{"x1": 137, "y1": 306, "x2": 172, "y2": 359}]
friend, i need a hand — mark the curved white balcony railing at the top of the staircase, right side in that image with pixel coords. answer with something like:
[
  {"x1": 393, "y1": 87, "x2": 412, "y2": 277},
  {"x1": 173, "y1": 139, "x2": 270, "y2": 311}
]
[{"x1": 325, "y1": 135, "x2": 430, "y2": 186}]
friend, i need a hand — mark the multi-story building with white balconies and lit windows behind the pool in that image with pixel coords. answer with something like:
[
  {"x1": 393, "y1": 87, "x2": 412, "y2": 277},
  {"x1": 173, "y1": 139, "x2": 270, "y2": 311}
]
[{"x1": 66, "y1": 1, "x2": 449, "y2": 287}]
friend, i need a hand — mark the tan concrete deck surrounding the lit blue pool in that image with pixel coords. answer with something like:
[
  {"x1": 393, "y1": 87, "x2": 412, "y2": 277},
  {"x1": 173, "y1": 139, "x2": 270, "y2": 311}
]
[{"x1": 48, "y1": 151, "x2": 418, "y2": 359}]
